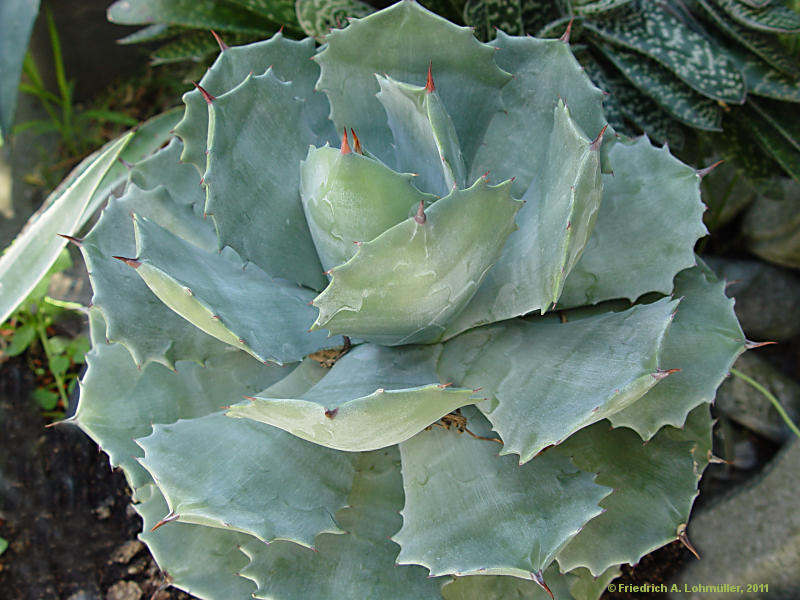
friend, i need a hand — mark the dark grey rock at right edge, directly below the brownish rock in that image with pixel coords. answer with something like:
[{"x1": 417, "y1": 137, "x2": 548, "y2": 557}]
[{"x1": 704, "y1": 257, "x2": 800, "y2": 342}]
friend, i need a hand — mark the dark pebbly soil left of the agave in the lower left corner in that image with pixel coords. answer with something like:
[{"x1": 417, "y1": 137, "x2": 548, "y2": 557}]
[{"x1": 0, "y1": 360, "x2": 190, "y2": 600}]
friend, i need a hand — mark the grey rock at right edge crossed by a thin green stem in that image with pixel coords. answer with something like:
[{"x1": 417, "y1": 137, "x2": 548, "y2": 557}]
[{"x1": 715, "y1": 352, "x2": 800, "y2": 443}]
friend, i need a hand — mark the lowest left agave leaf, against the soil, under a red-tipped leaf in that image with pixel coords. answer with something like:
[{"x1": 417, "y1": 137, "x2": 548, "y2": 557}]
[{"x1": 133, "y1": 484, "x2": 255, "y2": 598}]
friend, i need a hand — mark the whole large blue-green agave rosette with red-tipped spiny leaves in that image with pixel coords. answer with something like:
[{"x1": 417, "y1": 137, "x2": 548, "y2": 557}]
[{"x1": 65, "y1": 0, "x2": 747, "y2": 600}]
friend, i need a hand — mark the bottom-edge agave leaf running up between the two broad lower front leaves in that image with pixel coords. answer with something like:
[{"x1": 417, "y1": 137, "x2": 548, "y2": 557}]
[{"x1": 241, "y1": 447, "x2": 441, "y2": 600}]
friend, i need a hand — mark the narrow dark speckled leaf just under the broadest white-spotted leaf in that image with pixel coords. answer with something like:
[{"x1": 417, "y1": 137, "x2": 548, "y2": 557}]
[{"x1": 597, "y1": 42, "x2": 722, "y2": 131}]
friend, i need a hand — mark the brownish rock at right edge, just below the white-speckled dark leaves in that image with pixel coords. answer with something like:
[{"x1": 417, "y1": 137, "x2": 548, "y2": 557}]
[{"x1": 742, "y1": 179, "x2": 800, "y2": 268}]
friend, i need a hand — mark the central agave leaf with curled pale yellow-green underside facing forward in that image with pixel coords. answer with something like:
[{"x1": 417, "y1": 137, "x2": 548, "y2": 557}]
[{"x1": 227, "y1": 344, "x2": 474, "y2": 452}]
